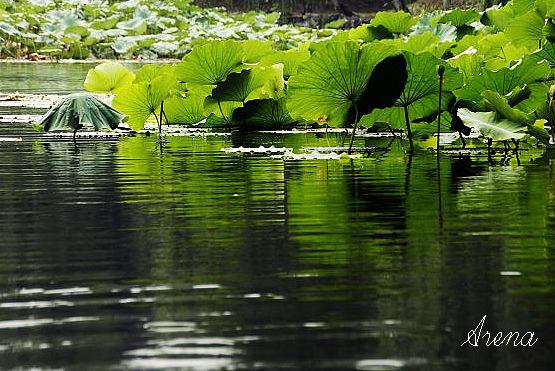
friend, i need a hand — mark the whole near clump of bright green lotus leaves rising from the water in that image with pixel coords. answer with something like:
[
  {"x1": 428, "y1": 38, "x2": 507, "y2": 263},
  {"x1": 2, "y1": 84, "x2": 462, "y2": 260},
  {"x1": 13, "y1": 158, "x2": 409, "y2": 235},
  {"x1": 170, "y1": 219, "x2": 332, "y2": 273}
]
[{"x1": 42, "y1": 0, "x2": 555, "y2": 152}]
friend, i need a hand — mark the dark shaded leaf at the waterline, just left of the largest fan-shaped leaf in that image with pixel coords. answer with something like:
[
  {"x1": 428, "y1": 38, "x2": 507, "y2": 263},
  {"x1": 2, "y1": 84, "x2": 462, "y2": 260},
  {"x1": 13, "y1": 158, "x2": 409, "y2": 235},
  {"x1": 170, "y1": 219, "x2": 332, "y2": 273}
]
[{"x1": 233, "y1": 98, "x2": 295, "y2": 129}]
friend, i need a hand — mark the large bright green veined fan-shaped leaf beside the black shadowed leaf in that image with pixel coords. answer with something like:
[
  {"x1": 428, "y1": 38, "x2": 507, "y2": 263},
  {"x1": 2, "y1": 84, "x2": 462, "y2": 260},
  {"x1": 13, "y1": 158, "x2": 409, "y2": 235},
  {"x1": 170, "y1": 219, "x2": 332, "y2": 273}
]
[{"x1": 287, "y1": 41, "x2": 398, "y2": 126}]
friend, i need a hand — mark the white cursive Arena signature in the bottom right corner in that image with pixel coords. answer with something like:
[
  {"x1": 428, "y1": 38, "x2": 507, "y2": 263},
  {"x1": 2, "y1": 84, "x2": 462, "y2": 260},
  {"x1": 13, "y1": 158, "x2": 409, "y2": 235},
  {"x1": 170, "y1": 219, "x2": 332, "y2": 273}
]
[{"x1": 461, "y1": 315, "x2": 539, "y2": 347}]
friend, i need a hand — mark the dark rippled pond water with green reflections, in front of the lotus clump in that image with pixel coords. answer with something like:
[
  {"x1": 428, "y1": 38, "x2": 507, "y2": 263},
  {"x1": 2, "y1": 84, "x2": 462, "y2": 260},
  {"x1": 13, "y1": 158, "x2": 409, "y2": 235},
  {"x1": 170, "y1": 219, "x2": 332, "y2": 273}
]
[{"x1": 0, "y1": 66, "x2": 555, "y2": 370}]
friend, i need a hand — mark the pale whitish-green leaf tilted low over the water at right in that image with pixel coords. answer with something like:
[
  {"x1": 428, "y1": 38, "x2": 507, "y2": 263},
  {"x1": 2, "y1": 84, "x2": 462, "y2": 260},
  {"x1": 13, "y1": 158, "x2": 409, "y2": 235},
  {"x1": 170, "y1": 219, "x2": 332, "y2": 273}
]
[{"x1": 457, "y1": 108, "x2": 526, "y2": 140}]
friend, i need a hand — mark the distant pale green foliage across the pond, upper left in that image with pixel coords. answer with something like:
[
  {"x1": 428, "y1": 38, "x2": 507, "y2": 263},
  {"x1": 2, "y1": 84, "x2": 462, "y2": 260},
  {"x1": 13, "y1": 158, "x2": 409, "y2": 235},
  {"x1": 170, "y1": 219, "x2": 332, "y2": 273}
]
[{"x1": 0, "y1": 0, "x2": 332, "y2": 59}]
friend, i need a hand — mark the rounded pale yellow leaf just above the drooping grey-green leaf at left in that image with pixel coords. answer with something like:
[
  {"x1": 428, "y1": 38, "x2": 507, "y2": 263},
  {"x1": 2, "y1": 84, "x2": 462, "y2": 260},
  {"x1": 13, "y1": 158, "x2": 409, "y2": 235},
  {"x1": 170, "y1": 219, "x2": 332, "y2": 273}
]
[{"x1": 83, "y1": 62, "x2": 135, "y2": 93}]
